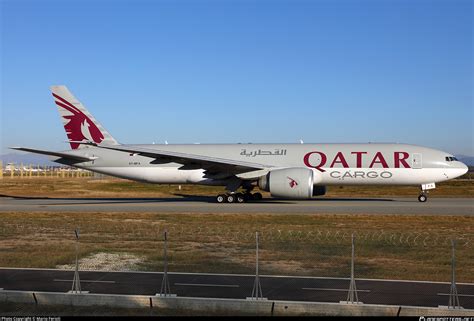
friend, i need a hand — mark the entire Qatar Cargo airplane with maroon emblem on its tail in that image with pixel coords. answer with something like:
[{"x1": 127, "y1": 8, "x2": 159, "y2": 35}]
[{"x1": 12, "y1": 86, "x2": 468, "y2": 203}]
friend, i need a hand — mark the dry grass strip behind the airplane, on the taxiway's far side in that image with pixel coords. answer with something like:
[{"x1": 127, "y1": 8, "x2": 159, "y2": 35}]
[{"x1": 0, "y1": 177, "x2": 474, "y2": 198}]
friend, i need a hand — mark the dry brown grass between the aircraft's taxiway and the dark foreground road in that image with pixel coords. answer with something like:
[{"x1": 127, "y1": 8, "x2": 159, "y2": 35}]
[{"x1": 0, "y1": 213, "x2": 474, "y2": 282}]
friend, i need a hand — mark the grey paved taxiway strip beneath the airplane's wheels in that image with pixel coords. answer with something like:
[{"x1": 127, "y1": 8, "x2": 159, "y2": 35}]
[{"x1": 0, "y1": 196, "x2": 474, "y2": 216}]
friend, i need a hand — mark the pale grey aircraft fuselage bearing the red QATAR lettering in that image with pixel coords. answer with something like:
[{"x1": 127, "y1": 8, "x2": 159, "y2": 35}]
[{"x1": 58, "y1": 143, "x2": 467, "y2": 185}]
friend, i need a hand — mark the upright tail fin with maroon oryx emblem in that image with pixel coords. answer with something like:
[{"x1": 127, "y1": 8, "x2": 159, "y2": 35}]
[{"x1": 51, "y1": 86, "x2": 119, "y2": 149}]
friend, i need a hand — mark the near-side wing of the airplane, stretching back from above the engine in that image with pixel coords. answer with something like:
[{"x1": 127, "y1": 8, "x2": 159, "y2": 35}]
[{"x1": 95, "y1": 145, "x2": 272, "y2": 179}]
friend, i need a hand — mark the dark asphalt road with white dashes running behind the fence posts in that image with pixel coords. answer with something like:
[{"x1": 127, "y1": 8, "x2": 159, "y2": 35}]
[{"x1": 0, "y1": 268, "x2": 474, "y2": 309}]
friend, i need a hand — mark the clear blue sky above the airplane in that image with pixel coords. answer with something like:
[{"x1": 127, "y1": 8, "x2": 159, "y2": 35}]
[{"x1": 0, "y1": 0, "x2": 474, "y2": 156}]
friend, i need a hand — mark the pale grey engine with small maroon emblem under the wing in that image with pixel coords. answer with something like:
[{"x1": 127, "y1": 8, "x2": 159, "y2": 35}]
[{"x1": 258, "y1": 167, "x2": 314, "y2": 199}]
